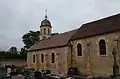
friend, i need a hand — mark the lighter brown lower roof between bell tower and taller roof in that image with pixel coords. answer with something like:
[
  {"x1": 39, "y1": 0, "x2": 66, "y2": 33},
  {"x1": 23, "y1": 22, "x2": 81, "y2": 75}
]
[{"x1": 28, "y1": 29, "x2": 78, "y2": 51}]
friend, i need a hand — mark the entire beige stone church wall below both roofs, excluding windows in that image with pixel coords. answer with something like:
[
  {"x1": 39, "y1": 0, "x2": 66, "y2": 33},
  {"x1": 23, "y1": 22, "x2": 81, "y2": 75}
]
[{"x1": 27, "y1": 32, "x2": 120, "y2": 76}]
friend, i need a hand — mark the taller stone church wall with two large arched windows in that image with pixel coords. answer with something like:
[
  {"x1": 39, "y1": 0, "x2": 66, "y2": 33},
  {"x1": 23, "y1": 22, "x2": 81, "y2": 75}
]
[{"x1": 73, "y1": 32, "x2": 120, "y2": 76}]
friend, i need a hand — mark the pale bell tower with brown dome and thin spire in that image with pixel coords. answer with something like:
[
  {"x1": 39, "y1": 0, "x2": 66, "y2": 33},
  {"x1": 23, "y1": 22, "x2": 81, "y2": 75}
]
[{"x1": 40, "y1": 10, "x2": 52, "y2": 40}]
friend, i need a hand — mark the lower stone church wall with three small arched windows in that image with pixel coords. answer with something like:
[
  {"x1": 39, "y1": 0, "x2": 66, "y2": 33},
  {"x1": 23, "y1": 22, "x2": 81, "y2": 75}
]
[{"x1": 27, "y1": 47, "x2": 67, "y2": 74}]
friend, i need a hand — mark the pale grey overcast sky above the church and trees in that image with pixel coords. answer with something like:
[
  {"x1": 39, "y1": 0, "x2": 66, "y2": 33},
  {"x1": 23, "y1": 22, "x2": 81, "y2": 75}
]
[{"x1": 0, "y1": 0, "x2": 120, "y2": 50}]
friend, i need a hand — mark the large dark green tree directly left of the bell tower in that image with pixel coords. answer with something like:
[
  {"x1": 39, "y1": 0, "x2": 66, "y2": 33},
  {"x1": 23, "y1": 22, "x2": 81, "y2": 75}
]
[{"x1": 22, "y1": 30, "x2": 40, "y2": 49}]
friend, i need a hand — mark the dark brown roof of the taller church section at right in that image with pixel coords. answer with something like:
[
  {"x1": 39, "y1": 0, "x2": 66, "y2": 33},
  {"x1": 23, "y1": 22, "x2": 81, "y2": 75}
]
[{"x1": 71, "y1": 14, "x2": 120, "y2": 40}]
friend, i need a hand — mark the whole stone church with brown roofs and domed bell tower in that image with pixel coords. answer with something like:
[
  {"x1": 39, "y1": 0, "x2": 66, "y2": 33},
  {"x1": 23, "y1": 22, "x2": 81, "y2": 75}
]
[{"x1": 27, "y1": 14, "x2": 120, "y2": 76}]
